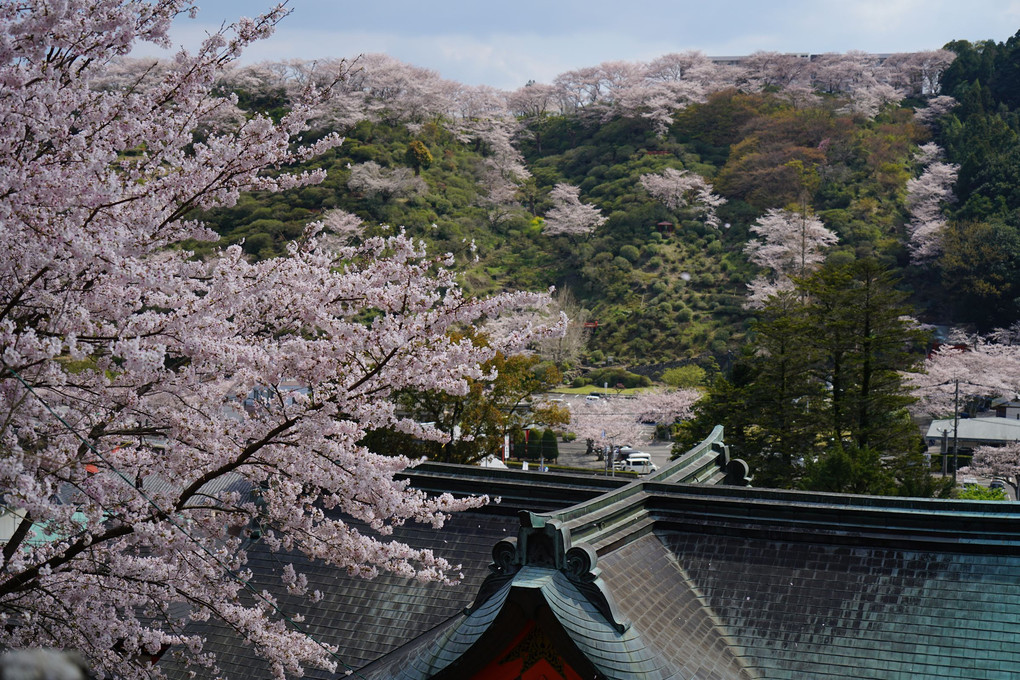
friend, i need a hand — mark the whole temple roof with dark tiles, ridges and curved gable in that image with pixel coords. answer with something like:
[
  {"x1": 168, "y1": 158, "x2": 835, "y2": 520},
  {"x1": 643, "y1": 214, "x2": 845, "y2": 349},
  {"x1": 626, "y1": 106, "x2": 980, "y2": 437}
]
[{"x1": 155, "y1": 430, "x2": 1020, "y2": 680}]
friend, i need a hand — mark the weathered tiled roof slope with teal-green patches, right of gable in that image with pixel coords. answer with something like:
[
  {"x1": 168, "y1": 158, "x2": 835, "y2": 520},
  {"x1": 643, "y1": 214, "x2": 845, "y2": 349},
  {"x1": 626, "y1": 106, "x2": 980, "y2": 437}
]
[{"x1": 660, "y1": 531, "x2": 1020, "y2": 680}]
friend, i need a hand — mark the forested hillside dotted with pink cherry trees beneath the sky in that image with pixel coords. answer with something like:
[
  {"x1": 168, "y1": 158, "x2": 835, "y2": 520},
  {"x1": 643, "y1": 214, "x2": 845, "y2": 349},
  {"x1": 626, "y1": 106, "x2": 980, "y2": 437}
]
[{"x1": 135, "y1": 38, "x2": 1020, "y2": 377}]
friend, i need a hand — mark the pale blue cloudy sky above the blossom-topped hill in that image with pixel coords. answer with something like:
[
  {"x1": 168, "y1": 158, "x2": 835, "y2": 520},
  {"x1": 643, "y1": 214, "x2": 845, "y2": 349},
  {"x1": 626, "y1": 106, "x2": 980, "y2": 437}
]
[{"x1": 143, "y1": 0, "x2": 1020, "y2": 90}]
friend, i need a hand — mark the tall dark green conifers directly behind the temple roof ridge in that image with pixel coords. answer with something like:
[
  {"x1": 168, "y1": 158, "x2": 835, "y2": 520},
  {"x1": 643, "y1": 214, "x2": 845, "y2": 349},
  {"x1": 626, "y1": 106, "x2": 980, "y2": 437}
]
[{"x1": 681, "y1": 260, "x2": 945, "y2": 495}]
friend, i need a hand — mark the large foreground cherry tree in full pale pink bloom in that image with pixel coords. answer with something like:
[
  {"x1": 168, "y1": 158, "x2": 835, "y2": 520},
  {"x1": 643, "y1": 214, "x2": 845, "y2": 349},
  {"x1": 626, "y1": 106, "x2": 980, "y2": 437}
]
[{"x1": 0, "y1": 0, "x2": 546, "y2": 678}]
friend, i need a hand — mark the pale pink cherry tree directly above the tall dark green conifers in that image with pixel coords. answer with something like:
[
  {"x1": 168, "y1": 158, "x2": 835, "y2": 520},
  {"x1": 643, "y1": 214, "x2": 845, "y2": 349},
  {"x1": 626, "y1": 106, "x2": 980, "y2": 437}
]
[{"x1": 744, "y1": 208, "x2": 838, "y2": 308}]
